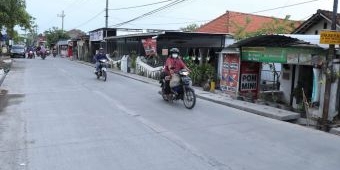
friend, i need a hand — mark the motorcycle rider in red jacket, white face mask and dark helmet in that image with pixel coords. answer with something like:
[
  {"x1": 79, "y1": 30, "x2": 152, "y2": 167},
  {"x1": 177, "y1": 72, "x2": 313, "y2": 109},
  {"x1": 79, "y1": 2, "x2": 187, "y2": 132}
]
[{"x1": 163, "y1": 48, "x2": 190, "y2": 95}]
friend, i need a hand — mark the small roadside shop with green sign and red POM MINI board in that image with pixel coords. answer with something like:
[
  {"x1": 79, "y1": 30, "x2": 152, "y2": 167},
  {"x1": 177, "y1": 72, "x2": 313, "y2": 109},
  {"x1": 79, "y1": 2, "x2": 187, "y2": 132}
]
[{"x1": 221, "y1": 35, "x2": 325, "y2": 108}]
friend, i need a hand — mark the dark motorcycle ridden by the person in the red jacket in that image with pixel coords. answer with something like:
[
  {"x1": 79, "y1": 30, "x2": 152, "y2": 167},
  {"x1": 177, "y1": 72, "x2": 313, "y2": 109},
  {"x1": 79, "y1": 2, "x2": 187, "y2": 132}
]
[{"x1": 159, "y1": 69, "x2": 196, "y2": 109}]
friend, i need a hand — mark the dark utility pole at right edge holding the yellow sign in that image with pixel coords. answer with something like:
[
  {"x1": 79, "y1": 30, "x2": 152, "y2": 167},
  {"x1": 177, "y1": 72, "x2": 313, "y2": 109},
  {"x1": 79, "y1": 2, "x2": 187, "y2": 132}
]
[{"x1": 321, "y1": 0, "x2": 338, "y2": 131}]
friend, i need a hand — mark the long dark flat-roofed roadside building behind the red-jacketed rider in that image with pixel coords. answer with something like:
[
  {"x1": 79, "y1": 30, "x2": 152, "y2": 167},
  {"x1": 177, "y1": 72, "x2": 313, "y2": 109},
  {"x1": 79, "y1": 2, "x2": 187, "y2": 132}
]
[{"x1": 105, "y1": 31, "x2": 231, "y2": 83}]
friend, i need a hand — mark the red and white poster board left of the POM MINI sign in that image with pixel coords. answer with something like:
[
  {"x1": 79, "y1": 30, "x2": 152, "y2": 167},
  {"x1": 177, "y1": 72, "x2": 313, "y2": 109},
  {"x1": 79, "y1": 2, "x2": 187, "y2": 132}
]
[{"x1": 220, "y1": 54, "x2": 240, "y2": 94}]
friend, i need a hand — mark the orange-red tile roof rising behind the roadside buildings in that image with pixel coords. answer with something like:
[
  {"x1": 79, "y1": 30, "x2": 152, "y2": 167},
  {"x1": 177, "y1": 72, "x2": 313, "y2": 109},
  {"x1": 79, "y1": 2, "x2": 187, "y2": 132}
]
[{"x1": 196, "y1": 11, "x2": 300, "y2": 34}]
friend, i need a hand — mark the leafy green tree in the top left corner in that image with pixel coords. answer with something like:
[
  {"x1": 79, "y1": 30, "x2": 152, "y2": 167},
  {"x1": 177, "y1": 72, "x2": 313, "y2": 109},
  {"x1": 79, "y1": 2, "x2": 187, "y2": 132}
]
[{"x1": 0, "y1": 0, "x2": 34, "y2": 38}]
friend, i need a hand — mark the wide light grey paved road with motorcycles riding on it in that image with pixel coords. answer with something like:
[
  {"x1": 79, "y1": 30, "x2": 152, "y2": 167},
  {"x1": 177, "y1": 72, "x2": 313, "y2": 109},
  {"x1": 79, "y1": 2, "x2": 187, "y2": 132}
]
[{"x1": 0, "y1": 57, "x2": 340, "y2": 170}]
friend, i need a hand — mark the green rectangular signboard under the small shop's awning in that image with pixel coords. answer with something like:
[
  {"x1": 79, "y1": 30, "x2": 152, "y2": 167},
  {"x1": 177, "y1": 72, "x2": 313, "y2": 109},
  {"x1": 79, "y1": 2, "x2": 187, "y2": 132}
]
[{"x1": 241, "y1": 47, "x2": 287, "y2": 63}]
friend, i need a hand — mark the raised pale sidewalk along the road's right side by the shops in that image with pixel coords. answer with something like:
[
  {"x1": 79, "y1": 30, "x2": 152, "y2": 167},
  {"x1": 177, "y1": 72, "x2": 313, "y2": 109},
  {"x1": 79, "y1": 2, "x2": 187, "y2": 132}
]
[{"x1": 78, "y1": 61, "x2": 300, "y2": 121}]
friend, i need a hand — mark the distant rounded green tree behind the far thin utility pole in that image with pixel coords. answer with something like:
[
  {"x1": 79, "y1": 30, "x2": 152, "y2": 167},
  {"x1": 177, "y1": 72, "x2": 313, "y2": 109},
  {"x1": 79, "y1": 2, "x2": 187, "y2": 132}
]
[{"x1": 44, "y1": 27, "x2": 70, "y2": 46}]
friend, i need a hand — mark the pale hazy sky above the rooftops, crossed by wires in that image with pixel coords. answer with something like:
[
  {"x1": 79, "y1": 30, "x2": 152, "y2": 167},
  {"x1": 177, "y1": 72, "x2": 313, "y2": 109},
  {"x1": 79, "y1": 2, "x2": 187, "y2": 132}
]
[{"x1": 26, "y1": 0, "x2": 340, "y2": 33}]
